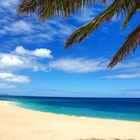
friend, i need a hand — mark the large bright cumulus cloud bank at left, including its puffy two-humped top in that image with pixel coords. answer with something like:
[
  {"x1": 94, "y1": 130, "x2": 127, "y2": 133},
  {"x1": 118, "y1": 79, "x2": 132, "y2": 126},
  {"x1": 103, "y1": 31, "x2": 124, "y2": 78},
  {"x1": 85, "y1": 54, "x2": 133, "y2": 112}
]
[{"x1": 0, "y1": 46, "x2": 52, "y2": 71}]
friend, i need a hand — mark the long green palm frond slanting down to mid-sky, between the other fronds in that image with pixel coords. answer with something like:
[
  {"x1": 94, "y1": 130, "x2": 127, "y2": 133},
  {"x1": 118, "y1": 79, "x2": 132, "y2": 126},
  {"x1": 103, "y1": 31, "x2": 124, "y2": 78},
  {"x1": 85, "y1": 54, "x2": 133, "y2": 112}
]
[{"x1": 65, "y1": 0, "x2": 137, "y2": 48}]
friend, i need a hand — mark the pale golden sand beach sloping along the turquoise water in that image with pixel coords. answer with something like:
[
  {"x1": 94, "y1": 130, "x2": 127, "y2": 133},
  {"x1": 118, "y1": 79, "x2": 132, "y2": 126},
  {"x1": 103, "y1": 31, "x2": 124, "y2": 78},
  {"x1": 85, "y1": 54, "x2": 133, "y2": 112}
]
[{"x1": 0, "y1": 101, "x2": 140, "y2": 140}]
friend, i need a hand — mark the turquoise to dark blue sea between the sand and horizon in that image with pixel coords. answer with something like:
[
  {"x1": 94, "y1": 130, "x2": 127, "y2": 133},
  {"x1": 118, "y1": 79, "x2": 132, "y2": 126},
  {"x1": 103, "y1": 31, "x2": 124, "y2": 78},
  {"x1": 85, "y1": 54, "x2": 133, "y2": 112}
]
[{"x1": 0, "y1": 96, "x2": 140, "y2": 121}]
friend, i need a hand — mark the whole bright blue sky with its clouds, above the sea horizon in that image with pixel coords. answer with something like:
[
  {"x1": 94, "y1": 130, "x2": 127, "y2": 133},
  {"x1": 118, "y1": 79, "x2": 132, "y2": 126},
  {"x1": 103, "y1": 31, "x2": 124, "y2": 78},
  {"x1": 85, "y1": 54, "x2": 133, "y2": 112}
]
[{"x1": 0, "y1": 0, "x2": 140, "y2": 97}]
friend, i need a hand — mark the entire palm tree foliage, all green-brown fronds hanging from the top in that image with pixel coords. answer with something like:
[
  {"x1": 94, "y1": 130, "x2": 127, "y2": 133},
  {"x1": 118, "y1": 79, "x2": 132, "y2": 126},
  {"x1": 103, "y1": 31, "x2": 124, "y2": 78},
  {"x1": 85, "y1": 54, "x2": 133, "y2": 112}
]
[{"x1": 17, "y1": 0, "x2": 140, "y2": 68}]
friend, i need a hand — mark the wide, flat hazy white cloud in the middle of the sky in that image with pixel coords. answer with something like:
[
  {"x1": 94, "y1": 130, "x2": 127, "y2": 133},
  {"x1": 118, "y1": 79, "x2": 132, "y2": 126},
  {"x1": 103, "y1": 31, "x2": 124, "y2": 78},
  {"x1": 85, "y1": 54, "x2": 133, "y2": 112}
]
[{"x1": 49, "y1": 58, "x2": 105, "y2": 73}]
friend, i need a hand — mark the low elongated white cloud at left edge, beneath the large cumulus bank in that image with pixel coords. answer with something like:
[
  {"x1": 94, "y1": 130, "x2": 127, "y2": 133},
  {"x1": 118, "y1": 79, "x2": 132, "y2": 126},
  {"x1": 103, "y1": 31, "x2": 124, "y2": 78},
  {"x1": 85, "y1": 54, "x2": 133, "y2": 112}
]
[{"x1": 0, "y1": 72, "x2": 30, "y2": 83}]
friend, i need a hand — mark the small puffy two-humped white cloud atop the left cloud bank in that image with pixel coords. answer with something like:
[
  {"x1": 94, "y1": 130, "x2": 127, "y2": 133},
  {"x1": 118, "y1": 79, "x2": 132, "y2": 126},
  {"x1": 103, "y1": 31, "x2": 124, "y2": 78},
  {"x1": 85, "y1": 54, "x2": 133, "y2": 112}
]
[{"x1": 15, "y1": 46, "x2": 52, "y2": 58}]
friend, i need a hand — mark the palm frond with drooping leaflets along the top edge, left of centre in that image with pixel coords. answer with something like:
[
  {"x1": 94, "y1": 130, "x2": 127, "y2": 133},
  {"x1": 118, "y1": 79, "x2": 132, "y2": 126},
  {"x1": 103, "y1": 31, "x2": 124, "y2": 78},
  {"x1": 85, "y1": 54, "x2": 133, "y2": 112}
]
[{"x1": 17, "y1": 0, "x2": 107, "y2": 21}]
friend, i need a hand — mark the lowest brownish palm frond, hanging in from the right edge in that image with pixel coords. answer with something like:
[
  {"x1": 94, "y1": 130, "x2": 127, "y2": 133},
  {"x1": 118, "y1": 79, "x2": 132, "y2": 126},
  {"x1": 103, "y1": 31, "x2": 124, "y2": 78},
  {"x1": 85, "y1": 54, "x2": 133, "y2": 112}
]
[{"x1": 108, "y1": 25, "x2": 140, "y2": 68}]
